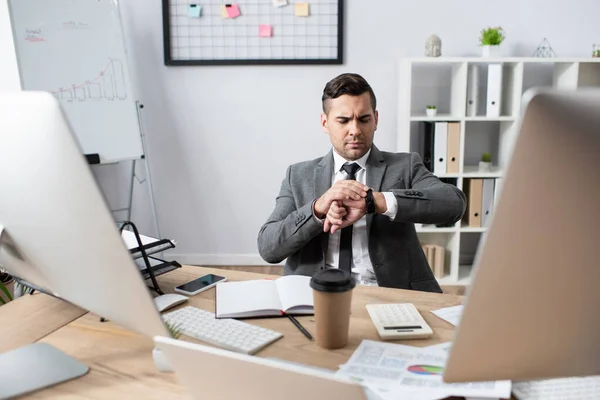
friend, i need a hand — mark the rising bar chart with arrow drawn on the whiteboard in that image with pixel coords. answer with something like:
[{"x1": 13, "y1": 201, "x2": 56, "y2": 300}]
[{"x1": 50, "y1": 58, "x2": 127, "y2": 101}]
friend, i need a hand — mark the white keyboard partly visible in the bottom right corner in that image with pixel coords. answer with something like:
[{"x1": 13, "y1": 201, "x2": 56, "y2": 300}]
[{"x1": 512, "y1": 376, "x2": 600, "y2": 400}]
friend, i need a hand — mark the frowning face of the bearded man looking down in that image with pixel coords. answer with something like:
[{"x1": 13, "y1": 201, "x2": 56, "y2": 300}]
[{"x1": 321, "y1": 92, "x2": 378, "y2": 161}]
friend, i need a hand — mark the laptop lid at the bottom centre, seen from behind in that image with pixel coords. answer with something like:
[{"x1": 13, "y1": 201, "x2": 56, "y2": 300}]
[{"x1": 154, "y1": 336, "x2": 373, "y2": 400}]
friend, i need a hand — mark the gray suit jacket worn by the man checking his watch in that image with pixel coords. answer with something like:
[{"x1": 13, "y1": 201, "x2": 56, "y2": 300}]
[{"x1": 258, "y1": 145, "x2": 466, "y2": 292}]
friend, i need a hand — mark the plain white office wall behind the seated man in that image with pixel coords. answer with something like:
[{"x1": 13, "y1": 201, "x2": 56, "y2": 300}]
[{"x1": 0, "y1": 0, "x2": 600, "y2": 264}]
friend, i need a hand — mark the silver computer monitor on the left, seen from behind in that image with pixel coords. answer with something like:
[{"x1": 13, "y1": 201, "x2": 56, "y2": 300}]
[{"x1": 0, "y1": 92, "x2": 168, "y2": 397}]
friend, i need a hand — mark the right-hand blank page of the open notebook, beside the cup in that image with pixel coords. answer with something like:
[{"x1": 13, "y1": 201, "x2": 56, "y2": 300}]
[{"x1": 275, "y1": 275, "x2": 314, "y2": 314}]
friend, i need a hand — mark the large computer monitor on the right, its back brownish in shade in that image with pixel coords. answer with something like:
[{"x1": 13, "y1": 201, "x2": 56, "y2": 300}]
[{"x1": 444, "y1": 89, "x2": 600, "y2": 382}]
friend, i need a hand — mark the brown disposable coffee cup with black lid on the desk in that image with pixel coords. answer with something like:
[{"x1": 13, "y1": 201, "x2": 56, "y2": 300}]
[{"x1": 310, "y1": 268, "x2": 356, "y2": 349}]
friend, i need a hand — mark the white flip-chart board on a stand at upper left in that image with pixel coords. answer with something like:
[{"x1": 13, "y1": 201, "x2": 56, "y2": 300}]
[{"x1": 9, "y1": 0, "x2": 143, "y2": 163}]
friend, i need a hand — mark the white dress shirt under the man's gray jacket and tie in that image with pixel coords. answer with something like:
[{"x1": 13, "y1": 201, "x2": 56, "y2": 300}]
[{"x1": 313, "y1": 149, "x2": 398, "y2": 285}]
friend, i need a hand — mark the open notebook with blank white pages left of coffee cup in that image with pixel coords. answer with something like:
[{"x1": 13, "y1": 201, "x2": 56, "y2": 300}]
[{"x1": 215, "y1": 275, "x2": 314, "y2": 318}]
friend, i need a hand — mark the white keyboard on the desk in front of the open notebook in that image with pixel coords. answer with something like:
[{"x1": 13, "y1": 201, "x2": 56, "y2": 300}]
[{"x1": 162, "y1": 306, "x2": 283, "y2": 354}]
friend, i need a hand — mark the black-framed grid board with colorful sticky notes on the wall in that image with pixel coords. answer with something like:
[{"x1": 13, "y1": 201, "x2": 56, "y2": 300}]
[{"x1": 163, "y1": 0, "x2": 344, "y2": 66}]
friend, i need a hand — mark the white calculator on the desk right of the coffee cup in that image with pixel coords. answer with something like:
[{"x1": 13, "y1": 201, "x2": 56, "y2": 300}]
[{"x1": 367, "y1": 303, "x2": 433, "y2": 340}]
